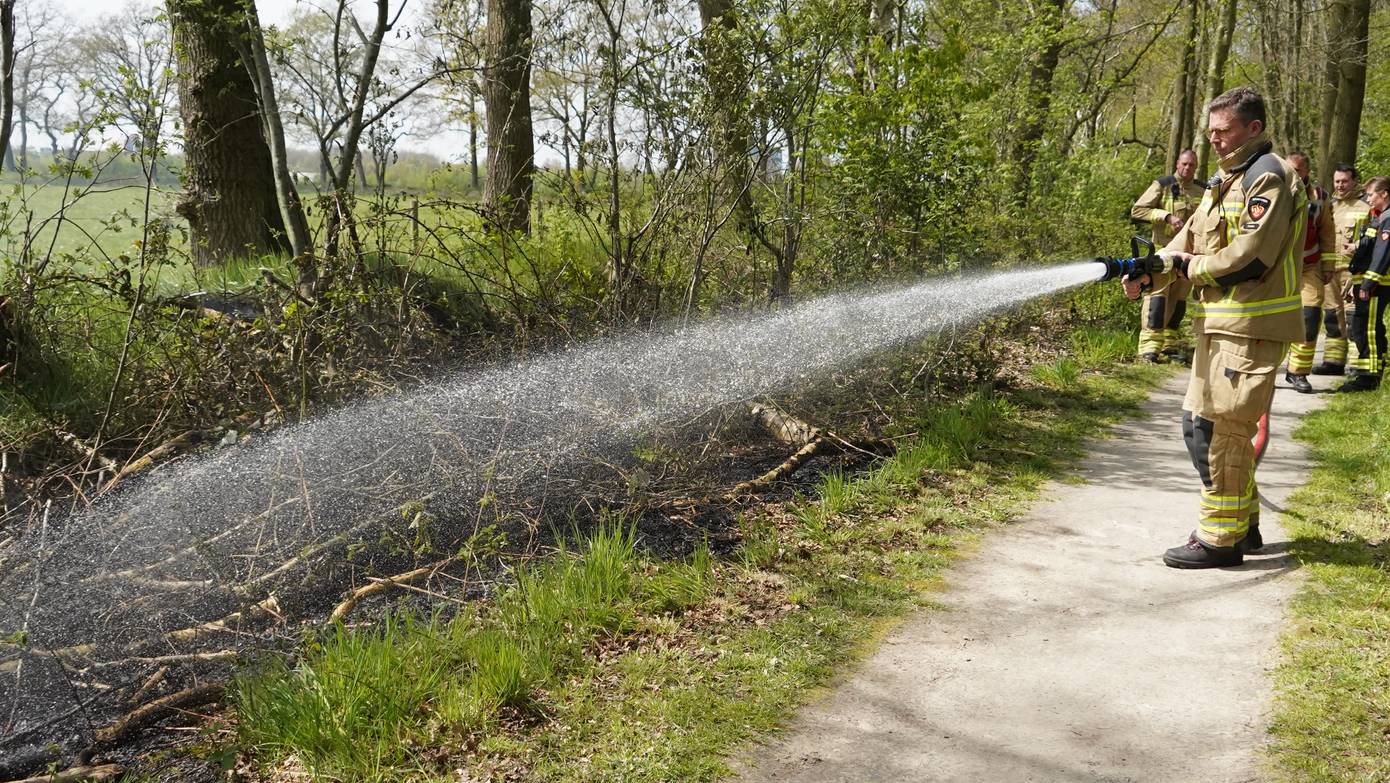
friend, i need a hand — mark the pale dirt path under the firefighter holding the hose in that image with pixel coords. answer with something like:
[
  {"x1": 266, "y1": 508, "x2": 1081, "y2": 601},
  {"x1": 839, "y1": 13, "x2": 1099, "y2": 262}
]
[{"x1": 742, "y1": 376, "x2": 1327, "y2": 783}]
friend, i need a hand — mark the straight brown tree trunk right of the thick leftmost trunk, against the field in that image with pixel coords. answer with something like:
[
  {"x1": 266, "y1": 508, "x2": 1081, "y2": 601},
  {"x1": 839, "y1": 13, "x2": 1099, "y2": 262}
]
[{"x1": 482, "y1": 0, "x2": 535, "y2": 232}]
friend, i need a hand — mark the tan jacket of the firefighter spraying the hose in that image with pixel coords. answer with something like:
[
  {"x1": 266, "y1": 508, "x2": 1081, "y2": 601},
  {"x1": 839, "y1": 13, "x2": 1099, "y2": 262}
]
[{"x1": 1168, "y1": 134, "x2": 1308, "y2": 342}]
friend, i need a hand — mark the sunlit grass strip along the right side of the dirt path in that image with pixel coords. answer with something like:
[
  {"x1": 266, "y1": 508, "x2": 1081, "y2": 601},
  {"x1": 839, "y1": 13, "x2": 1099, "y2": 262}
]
[{"x1": 1270, "y1": 388, "x2": 1390, "y2": 783}]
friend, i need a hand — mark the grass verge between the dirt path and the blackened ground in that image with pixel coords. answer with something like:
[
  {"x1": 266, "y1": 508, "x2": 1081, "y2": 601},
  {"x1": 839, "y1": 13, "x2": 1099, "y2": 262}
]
[{"x1": 227, "y1": 322, "x2": 1168, "y2": 782}]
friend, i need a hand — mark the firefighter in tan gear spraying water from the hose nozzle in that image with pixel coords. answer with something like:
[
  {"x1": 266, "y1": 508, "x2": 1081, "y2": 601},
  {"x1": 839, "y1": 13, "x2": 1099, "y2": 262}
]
[{"x1": 1125, "y1": 86, "x2": 1307, "y2": 569}]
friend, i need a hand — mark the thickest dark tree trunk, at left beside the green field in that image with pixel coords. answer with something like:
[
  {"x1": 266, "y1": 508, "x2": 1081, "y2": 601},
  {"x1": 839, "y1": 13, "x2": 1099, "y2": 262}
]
[{"x1": 168, "y1": 0, "x2": 291, "y2": 266}]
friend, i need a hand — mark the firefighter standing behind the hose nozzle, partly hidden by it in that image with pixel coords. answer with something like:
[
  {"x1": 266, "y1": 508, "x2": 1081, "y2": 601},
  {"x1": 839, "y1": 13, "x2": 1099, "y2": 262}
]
[{"x1": 1130, "y1": 150, "x2": 1205, "y2": 362}]
